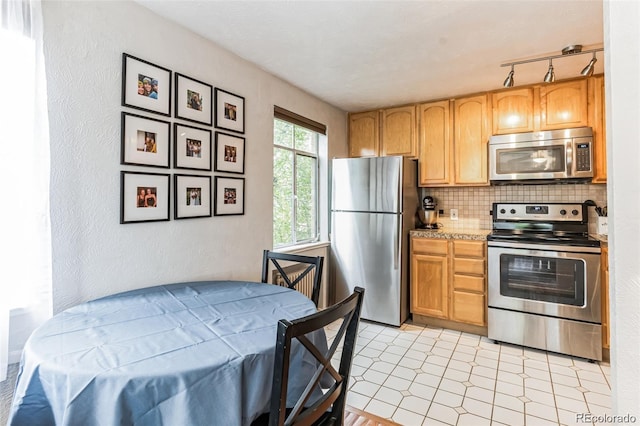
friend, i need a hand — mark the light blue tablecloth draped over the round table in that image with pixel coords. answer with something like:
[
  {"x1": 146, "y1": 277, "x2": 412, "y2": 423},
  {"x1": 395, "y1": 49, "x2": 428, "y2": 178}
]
[{"x1": 9, "y1": 281, "x2": 326, "y2": 426}]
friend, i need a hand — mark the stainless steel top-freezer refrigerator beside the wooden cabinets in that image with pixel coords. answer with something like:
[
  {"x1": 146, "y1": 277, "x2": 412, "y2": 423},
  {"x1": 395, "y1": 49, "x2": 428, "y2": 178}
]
[{"x1": 331, "y1": 157, "x2": 418, "y2": 326}]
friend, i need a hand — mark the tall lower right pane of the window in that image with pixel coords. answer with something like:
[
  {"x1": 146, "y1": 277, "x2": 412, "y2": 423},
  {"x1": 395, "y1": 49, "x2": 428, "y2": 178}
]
[{"x1": 296, "y1": 154, "x2": 317, "y2": 241}]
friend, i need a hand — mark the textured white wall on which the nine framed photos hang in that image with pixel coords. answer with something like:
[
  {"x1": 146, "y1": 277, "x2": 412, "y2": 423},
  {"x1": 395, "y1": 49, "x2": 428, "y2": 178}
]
[{"x1": 43, "y1": 1, "x2": 347, "y2": 312}]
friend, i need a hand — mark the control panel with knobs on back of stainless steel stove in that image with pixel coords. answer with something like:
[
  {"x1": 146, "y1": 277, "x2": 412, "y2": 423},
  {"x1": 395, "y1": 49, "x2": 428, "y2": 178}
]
[{"x1": 493, "y1": 203, "x2": 586, "y2": 222}]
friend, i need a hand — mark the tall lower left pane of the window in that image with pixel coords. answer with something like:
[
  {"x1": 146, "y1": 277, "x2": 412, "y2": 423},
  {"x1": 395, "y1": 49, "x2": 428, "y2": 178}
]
[{"x1": 273, "y1": 147, "x2": 294, "y2": 246}]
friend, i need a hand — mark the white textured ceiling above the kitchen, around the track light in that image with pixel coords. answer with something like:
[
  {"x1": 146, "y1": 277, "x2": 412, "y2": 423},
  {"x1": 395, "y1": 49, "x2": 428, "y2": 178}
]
[{"x1": 136, "y1": 0, "x2": 604, "y2": 112}]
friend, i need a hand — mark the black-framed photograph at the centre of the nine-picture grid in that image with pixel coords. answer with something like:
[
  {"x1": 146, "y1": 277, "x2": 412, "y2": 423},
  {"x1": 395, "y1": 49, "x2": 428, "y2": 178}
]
[{"x1": 173, "y1": 123, "x2": 211, "y2": 171}]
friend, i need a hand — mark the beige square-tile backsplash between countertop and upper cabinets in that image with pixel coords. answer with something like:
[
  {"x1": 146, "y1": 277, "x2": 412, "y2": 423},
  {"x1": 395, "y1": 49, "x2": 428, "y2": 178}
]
[{"x1": 420, "y1": 184, "x2": 607, "y2": 233}]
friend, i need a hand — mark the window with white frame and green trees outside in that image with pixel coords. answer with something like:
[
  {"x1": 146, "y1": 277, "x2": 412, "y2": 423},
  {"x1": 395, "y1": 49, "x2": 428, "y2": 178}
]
[{"x1": 273, "y1": 107, "x2": 325, "y2": 247}]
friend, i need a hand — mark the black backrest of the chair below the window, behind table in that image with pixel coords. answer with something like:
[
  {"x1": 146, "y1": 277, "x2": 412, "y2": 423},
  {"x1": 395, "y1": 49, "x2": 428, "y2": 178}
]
[{"x1": 262, "y1": 250, "x2": 324, "y2": 306}]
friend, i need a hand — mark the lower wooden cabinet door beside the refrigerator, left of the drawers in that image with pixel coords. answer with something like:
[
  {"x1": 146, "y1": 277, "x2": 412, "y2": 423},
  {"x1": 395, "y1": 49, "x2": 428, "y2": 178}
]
[{"x1": 411, "y1": 254, "x2": 449, "y2": 318}]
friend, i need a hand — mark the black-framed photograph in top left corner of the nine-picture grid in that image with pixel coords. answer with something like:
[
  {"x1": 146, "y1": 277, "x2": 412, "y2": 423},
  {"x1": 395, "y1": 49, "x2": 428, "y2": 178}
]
[{"x1": 122, "y1": 53, "x2": 171, "y2": 117}]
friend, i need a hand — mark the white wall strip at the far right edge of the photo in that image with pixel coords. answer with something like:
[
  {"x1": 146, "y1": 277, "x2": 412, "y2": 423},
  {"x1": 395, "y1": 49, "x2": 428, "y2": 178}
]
[{"x1": 604, "y1": 0, "x2": 640, "y2": 416}]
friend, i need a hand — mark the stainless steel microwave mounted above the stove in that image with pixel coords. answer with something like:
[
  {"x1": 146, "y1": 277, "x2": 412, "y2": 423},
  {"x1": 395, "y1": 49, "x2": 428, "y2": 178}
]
[{"x1": 489, "y1": 127, "x2": 593, "y2": 184}]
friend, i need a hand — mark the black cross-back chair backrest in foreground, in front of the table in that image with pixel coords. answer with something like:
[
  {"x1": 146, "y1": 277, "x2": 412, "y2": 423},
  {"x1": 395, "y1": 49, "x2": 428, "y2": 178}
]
[{"x1": 269, "y1": 287, "x2": 364, "y2": 426}]
